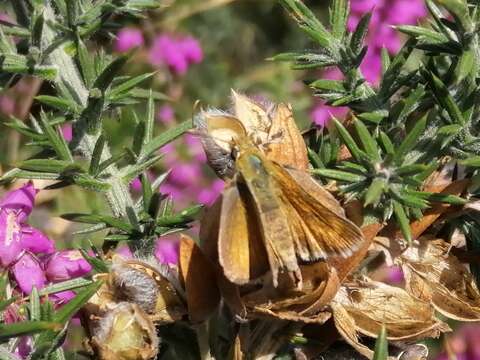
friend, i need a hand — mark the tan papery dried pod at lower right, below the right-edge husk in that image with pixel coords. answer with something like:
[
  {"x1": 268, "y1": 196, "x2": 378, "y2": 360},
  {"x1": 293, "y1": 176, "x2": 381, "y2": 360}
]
[{"x1": 330, "y1": 278, "x2": 450, "y2": 357}]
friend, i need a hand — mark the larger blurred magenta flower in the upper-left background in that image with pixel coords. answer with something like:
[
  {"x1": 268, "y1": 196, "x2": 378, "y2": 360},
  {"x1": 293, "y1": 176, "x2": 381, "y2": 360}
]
[{"x1": 149, "y1": 34, "x2": 203, "y2": 75}]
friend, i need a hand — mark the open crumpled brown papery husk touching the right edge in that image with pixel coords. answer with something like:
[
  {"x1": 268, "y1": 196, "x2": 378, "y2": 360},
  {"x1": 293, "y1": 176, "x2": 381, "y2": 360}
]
[{"x1": 399, "y1": 239, "x2": 480, "y2": 321}]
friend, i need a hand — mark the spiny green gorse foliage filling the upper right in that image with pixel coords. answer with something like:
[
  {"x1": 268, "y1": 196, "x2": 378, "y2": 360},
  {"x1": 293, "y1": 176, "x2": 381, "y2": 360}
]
[{"x1": 280, "y1": 0, "x2": 480, "y2": 241}]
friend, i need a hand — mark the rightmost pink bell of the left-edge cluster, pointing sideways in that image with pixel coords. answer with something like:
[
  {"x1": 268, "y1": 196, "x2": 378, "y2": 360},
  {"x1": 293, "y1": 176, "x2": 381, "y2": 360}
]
[{"x1": 45, "y1": 250, "x2": 92, "y2": 282}]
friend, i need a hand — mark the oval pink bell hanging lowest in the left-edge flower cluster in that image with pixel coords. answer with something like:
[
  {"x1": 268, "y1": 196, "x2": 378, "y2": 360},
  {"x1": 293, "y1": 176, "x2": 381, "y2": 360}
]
[{"x1": 11, "y1": 251, "x2": 47, "y2": 294}]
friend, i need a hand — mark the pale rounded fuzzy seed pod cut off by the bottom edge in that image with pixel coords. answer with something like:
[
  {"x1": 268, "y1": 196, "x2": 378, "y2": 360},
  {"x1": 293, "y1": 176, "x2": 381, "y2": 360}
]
[{"x1": 91, "y1": 302, "x2": 159, "y2": 360}]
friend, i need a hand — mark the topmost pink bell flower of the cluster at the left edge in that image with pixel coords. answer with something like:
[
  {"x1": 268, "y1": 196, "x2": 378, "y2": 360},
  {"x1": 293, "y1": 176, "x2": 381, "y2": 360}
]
[{"x1": 0, "y1": 181, "x2": 37, "y2": 223}]
